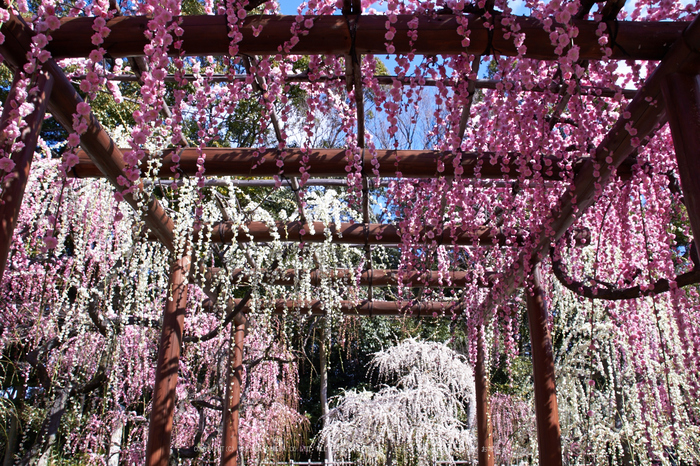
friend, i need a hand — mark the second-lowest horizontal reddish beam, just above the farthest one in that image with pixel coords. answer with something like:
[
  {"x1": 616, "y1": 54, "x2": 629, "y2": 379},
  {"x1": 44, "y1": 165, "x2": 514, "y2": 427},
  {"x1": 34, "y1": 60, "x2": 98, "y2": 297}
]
[{"x1": 200, "y1": 268, "x2": 494, "y2": 288}]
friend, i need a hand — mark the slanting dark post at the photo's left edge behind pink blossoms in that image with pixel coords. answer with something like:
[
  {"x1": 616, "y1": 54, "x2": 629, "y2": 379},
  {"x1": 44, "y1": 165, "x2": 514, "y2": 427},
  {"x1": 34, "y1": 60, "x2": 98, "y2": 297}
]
[{"x1": 0, "y1": 71, "x2": 53, "y2": 280}]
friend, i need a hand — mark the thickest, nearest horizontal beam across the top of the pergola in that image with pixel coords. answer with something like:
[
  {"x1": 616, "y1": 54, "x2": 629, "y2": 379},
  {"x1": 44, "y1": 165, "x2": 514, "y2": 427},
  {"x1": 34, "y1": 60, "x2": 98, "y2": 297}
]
[{"x1": 47, "y1": 15, "x2": 687, "y2": 60}]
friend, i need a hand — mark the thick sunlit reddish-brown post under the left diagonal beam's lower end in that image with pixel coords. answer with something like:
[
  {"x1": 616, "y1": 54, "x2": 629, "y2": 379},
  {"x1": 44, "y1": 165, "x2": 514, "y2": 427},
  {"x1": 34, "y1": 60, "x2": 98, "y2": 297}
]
[{"x1": 146, "y1": 255, "x2": 190, "y2": 466}]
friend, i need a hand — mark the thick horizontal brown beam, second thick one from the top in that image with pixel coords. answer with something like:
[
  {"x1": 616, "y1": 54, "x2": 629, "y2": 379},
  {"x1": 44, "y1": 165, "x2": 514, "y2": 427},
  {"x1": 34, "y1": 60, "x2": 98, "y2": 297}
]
[{"x1": 71, "y1": 147, "x2": 635, "y2": 181}]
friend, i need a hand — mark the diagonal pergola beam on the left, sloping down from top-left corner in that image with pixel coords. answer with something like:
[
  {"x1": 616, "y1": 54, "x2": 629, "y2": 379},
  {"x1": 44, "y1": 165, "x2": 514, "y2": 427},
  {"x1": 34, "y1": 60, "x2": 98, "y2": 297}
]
[{"x1": 0, "y1": 13, "x2": 173, "y2": 250}]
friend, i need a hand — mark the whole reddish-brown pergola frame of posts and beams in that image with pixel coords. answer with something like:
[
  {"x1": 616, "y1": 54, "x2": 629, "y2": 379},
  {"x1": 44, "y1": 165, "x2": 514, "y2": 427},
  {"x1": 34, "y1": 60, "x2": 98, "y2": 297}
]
[{"x1": 0, "y1": 0, "x2": 700, "y2": 466}]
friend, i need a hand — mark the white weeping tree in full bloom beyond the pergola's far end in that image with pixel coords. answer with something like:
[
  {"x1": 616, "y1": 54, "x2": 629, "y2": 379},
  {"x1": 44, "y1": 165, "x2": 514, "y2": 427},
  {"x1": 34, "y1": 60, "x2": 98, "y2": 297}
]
[{"x1": 317, "y1": 339, "x2": 475, "y2": 465}]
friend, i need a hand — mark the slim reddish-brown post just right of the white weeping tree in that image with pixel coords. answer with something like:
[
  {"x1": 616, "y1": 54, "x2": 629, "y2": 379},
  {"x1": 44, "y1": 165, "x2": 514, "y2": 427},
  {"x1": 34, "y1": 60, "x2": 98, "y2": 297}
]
[{"x1": 474, "y1": 326, "x2": 494, "y2": 466}]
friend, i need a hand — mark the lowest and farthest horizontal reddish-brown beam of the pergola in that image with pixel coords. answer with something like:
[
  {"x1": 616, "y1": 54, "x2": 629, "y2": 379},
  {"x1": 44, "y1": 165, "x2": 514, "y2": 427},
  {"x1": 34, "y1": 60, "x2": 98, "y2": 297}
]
[{"x1": 234, "y1": 299, "x2": 461, "y2": 317}]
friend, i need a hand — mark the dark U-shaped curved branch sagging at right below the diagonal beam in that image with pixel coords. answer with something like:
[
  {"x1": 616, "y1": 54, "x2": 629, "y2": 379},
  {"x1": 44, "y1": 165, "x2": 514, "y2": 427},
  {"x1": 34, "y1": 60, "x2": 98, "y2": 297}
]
[{"x1": 550, "y1": 244, "x2": 700, "y2": 301}]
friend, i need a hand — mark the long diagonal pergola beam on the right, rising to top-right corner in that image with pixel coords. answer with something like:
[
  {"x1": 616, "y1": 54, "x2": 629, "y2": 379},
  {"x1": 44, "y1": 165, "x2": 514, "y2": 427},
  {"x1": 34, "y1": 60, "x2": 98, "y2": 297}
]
[{"x1": 481, "y1": 13, "x2": 700, "y2": 313}]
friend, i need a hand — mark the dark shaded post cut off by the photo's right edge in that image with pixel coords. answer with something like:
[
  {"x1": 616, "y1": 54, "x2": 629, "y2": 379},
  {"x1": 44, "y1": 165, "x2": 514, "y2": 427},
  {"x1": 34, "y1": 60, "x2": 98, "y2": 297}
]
[{"x1": 661, "y1": 73, "x2": 700, "y2": 255}]
